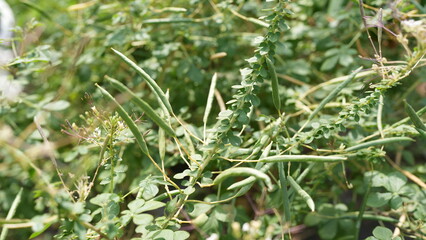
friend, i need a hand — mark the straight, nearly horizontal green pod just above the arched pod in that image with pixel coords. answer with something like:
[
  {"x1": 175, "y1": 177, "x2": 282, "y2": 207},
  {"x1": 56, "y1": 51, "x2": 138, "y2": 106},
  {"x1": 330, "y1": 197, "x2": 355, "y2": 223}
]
[{"x1": 259, "y1": 155, "x2": 347, "y2": 162}]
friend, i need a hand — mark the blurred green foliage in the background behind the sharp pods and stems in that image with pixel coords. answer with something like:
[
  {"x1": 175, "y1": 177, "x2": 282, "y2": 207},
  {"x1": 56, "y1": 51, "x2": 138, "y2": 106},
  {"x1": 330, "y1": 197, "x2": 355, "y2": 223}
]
[{"x1": 0, "y1": 0, "x2": 426, "y2": 239}]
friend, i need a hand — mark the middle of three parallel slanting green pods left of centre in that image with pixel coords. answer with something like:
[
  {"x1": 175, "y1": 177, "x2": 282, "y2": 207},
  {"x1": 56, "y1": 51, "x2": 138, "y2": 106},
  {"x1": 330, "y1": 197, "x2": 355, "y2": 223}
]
[{"x1": 105, "y1": 76, "x2": 176, "y2": 137}]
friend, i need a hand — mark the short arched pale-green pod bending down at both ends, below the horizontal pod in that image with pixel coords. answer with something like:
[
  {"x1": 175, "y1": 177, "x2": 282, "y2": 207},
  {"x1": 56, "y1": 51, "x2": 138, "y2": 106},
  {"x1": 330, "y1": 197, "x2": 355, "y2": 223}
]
[{"x1": 213, "y1": 167, "x2": 273, "y2": 190}]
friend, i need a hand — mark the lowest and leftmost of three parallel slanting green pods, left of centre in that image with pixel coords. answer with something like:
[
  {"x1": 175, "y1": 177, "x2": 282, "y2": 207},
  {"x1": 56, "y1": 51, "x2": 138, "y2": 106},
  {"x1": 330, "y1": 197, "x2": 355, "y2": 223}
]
[{"x1": 96, "y1": 84, "x2": 150, "y2": 156}]
